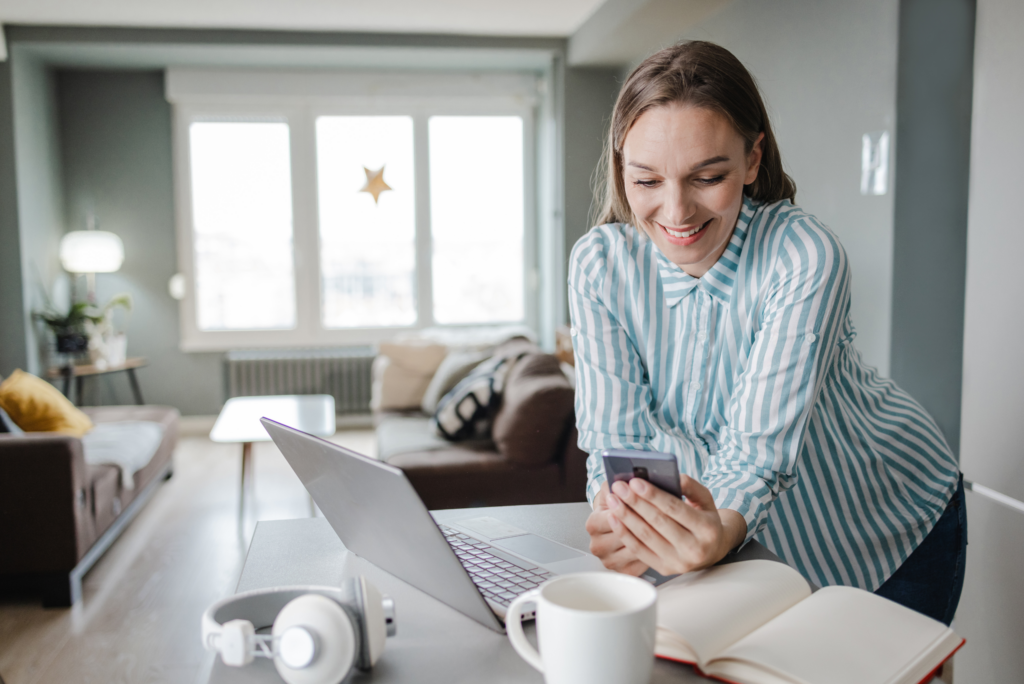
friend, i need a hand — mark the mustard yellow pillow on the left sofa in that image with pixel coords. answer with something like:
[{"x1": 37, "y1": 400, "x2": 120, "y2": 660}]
[{"x1": 0, "y1": 370, "x2": 92, "y2": 437}]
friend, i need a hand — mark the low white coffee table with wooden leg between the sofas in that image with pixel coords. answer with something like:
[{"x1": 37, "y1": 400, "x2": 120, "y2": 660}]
[{"x1": 210, "y1": 394, "x2": 336, "y2": 511}]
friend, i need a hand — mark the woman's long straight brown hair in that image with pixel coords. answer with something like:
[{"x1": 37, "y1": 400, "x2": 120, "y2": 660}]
[{"x1": 596, "y1": 41, "x2": 797, "y2": 224}]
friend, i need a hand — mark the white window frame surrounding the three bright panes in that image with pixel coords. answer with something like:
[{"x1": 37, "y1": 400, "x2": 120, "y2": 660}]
[{"x1": 167, "y1": 70, "x2": 541, "y2": 351}]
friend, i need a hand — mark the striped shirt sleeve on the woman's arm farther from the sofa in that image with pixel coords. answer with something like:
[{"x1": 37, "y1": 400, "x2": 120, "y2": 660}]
[{"x1": 702, "y1": 219, "x2": 850, "y2": 541}]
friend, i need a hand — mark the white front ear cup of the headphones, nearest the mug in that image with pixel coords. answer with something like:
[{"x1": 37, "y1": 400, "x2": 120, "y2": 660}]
[{"x1": 272, "y1": 594, "x2": 359, "y2": 684}]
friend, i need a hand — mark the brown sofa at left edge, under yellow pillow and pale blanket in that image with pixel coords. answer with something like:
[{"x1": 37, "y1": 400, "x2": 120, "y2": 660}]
[{"x1": 0, "y1": 405, "x2": 179, "y2": 606}]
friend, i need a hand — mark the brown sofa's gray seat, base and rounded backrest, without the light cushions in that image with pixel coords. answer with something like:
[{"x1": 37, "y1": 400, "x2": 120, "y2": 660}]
[{"x1": 375, "y1": 353, "x2": 587, "y2": 509}]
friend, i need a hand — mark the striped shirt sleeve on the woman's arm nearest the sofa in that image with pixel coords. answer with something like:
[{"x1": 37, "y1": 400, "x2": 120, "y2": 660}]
[{"x1": 568, "y1": 229, "x2": 654, "y2": 505}]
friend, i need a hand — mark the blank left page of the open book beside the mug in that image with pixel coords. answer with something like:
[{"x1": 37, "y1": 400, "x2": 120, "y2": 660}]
[{"x1": 654, "y1": 560, "x2": 811, "y2": 667}]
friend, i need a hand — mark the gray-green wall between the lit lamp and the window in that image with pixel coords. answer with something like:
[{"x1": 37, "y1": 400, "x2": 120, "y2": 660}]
[{"x1": 57, "y1": 71, "x2": 223, "y2": 415}]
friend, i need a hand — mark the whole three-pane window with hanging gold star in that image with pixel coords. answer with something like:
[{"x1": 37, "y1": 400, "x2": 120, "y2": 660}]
[{"x1": 168, "y1": 73, "x2": 537, "y2": 350}]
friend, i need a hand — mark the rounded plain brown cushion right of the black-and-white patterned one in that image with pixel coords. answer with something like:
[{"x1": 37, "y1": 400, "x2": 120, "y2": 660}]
[{"x1": 492, "y1": 353, "x2": 575, "y2": 466}]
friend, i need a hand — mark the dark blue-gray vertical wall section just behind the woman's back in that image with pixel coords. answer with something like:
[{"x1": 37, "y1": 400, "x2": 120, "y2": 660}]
[{"x1": 892, "y1": 0, "x2": 975, "y2": 453}]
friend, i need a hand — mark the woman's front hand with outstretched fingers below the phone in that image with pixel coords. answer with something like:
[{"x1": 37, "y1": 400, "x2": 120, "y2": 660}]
[{"x1": 602, "y1": 475, "x2": 746, "y2": 574}]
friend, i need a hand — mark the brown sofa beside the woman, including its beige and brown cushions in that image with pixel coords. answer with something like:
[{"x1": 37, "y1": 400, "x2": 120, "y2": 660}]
[{"x1": 373, "y1": 338, "x2": 587, "y2": 509}]
